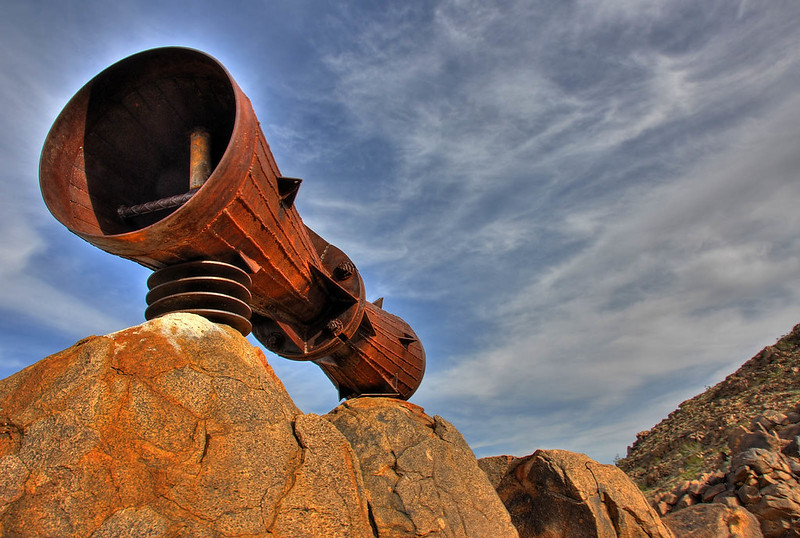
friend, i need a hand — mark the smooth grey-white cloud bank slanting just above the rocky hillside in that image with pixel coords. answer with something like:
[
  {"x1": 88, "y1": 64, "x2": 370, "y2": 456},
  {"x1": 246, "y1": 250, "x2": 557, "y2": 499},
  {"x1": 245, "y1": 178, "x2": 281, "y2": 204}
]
[{"x1": 424, "y1": 91, "x2": 800, "y2": 456}]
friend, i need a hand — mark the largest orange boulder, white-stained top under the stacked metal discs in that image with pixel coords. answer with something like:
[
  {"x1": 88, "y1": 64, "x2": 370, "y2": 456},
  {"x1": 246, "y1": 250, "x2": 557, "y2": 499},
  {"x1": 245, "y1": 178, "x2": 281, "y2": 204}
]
[{"x1": 0, "y1": 314, "x2": 372, "y2": 537}]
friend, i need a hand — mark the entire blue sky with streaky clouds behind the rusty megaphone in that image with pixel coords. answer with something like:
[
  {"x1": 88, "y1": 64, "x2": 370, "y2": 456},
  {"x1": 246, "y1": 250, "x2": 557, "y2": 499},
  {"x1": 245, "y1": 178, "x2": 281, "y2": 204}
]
[{"x1": 0, "y1": 0, "x2": 800, "y2": 462}]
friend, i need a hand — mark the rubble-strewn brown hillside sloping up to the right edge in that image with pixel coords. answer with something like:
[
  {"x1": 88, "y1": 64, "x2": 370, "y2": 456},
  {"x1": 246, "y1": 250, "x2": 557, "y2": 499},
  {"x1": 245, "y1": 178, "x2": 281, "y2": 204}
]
[{"x1": 618, "y1": 325, "x2": 800, "y2": 536}]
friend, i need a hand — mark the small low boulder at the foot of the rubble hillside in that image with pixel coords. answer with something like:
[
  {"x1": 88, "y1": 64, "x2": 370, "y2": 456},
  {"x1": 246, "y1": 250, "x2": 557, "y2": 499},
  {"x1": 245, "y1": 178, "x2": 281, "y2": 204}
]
[{"x1": 661, "y1": 503, "x2": 764, "y2": 538}]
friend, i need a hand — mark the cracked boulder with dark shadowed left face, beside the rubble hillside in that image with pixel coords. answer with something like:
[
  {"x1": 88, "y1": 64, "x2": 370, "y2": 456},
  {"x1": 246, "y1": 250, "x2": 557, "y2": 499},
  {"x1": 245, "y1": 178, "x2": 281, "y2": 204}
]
[{"x1": 492, "y1": 450, "x2": 673, "y2": 538}]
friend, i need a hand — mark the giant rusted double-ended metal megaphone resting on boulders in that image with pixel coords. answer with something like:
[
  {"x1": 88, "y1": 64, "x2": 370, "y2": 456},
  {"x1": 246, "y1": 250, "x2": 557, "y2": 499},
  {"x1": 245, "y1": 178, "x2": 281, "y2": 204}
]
[{"x1": 40, "y1": 48, "x2": 425, "y2": 398}]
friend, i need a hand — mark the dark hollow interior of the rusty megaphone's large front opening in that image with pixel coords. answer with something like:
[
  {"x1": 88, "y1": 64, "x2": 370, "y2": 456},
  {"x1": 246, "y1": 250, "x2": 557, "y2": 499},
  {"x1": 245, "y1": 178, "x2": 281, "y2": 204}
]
[{"x1": 40, "y1": 48, "x2": 236, "y2": 235}]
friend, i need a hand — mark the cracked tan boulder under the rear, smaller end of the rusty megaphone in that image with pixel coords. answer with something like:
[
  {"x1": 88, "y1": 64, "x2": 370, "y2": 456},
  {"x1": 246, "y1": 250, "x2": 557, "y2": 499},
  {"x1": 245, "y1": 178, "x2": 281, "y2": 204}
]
[{"x1": 325, "y1": 398, "x2": 517, "y2": 538}]
